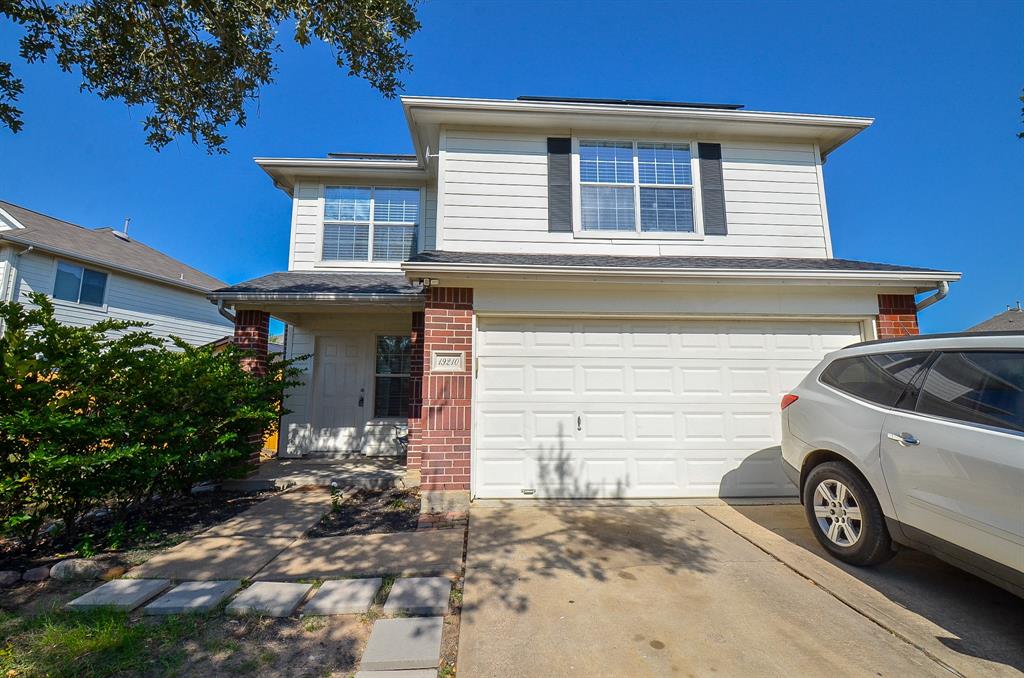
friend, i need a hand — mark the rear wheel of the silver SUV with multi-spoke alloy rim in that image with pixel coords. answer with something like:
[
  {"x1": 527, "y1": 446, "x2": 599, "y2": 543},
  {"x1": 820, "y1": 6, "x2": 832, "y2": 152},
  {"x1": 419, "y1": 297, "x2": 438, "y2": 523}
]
[{"x1": 804, "y1": 462, "x2": 894, "y2": 565}]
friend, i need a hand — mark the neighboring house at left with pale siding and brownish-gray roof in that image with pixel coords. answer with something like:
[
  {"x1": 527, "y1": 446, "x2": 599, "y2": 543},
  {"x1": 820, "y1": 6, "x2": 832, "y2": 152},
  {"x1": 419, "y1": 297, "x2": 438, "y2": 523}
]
[{"x1": 0, "y1": 201, "x2": 231, "y2": 345}]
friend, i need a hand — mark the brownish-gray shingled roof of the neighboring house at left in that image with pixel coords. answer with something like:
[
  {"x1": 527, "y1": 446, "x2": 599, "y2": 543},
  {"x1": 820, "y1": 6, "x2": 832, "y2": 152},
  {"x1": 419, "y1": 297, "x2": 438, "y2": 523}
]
[{"x1": 0, "y1": 201, "x2": 224, "y2": 291}]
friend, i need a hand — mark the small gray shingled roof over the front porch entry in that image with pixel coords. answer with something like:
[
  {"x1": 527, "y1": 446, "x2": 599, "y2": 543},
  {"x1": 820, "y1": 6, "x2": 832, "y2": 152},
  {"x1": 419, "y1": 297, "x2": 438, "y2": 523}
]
[{"x1": 210, "y1": 270, "x2": 423, "y2": 298}]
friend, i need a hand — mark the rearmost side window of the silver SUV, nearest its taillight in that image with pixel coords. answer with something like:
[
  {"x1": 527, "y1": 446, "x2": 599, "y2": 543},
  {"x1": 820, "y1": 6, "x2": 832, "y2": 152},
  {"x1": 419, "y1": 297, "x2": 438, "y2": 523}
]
[{"x1": 821, "y1": 351, "x2": 931, "y2": 408}]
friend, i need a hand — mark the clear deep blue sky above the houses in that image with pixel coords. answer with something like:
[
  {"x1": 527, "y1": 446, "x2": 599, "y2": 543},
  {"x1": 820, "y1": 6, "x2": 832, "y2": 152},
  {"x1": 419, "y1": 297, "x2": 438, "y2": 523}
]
[{"x1": 0, "y1": 0, "x2": 1024, "y2": 332}]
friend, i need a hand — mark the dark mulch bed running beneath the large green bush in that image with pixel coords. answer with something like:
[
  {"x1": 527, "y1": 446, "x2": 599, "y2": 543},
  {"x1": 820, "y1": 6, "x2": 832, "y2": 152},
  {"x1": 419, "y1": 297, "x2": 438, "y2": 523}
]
[{"x1": 0, "y1": 491, "x2": 274, "y2": 569}]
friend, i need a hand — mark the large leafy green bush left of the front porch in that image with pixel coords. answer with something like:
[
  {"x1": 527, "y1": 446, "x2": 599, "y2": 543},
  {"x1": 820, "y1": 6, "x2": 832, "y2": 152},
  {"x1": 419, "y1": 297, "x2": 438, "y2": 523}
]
[{"x1": 0, "y1": 295, "x2": 298, "y2": 548}]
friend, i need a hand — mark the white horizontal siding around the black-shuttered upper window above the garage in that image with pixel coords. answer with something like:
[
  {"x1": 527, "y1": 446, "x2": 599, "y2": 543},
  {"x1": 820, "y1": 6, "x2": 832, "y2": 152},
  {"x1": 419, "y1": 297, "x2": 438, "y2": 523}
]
[{"x1": 440, "y1": 130, "x2": 828, "y2": 257}]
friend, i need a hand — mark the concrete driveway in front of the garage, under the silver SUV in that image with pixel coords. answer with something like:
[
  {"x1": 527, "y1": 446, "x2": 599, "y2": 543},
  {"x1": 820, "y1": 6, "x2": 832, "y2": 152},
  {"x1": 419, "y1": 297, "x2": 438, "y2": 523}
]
[{"x1": 459, "y1": 503, "x2": 1024, "y2": 678}]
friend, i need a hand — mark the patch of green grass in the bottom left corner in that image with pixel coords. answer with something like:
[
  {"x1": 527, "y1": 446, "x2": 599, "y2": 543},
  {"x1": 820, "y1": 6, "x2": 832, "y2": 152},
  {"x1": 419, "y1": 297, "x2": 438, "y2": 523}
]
[{"x1": 0, "y1": 609, "x2": 205, "y2": 677}]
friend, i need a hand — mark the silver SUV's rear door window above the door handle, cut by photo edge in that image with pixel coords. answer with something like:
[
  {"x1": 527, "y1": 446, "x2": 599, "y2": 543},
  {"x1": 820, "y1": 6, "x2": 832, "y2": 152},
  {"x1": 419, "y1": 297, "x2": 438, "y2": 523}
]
[{"x1": 915, "y1": 351, "x2": 1024, "y2": 431}]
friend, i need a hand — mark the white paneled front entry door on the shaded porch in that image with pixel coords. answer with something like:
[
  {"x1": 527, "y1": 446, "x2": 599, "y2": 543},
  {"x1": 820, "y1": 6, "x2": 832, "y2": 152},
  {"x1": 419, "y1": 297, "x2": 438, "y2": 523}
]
[{"x1": 309, "y1": 334, "x2": 373, "y2": 452}]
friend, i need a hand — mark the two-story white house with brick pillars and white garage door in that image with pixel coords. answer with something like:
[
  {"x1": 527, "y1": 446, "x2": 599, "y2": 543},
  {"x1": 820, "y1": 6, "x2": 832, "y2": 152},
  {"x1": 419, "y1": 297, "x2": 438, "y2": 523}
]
[{"x1": 211, "y1": 96, "x2": 959, "y2": 498}]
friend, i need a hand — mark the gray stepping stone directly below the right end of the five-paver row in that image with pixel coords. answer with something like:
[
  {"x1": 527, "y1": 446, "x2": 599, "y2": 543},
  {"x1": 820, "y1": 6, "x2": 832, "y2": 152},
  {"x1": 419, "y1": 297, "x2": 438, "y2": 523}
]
[{"x1": 359, "y1": 617, "x2": 444, "y2": 675}]
